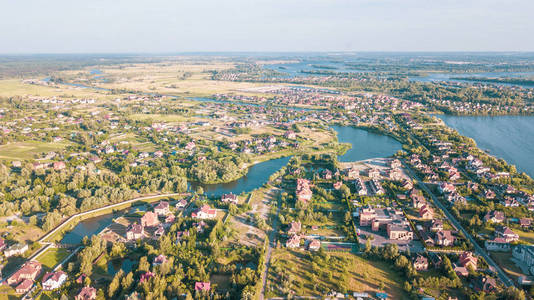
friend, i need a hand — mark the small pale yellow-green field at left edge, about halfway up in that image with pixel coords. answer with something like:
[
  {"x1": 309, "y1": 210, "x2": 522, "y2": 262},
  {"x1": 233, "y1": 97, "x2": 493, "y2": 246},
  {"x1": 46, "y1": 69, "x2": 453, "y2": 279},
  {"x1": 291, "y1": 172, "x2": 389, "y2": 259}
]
[{"x1": 0, "y1": 141, "x2": 69, "y2": 160}]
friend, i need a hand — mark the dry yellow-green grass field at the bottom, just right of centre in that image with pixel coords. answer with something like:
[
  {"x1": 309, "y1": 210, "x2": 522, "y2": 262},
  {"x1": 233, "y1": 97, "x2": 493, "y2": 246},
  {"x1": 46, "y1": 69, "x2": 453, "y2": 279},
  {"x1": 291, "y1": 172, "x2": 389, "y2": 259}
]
[{"x1": 266, "y1": 249, "x2": 406, "y2": 299}]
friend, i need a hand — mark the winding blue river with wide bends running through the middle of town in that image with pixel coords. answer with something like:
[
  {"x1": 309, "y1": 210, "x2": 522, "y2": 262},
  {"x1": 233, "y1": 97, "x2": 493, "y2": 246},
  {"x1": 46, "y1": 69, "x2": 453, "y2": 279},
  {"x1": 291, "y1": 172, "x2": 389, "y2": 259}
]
[{"x1": 61, "y1": 126, "x2": 401, "y2": 245}]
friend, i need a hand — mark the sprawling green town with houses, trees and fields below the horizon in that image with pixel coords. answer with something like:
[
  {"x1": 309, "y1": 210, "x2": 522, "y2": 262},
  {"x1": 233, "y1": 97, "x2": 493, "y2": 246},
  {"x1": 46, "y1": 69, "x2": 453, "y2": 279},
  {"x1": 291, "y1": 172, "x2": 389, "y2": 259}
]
[{"x1": 0, "y1": 51, "x2": 534, "y2": 300}]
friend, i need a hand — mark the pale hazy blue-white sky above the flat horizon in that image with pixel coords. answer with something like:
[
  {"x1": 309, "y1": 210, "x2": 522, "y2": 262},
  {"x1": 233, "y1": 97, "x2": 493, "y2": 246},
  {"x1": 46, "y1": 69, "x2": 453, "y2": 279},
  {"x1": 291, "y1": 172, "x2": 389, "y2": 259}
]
[{"x1": 0, "y1": 0, "x2": 534, "y2": 54}]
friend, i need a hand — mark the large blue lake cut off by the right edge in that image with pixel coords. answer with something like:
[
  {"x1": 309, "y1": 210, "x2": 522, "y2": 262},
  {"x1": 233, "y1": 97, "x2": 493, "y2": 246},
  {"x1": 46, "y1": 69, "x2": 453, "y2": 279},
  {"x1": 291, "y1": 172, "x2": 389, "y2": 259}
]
[{"x1": 436, "y1": 115, "x2": 534, "y2": 178}]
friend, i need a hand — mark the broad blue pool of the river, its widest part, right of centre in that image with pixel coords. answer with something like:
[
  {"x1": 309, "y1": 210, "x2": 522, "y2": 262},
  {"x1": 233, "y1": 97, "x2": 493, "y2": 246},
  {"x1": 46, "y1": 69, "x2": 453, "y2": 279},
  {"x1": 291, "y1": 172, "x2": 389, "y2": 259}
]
[{"x1": 332, "y1": 126, "x2": 402, "y2": 162}]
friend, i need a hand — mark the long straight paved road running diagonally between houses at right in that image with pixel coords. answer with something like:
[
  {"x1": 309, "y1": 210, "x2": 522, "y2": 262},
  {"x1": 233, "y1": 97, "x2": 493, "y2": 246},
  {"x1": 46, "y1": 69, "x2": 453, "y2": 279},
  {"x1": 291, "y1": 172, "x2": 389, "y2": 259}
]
[{"x1": 405, "y1": 164, "x2": 514, "y2": 287}]
